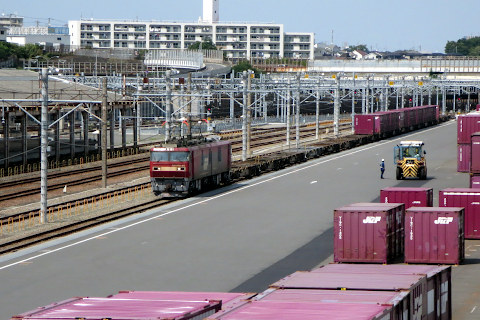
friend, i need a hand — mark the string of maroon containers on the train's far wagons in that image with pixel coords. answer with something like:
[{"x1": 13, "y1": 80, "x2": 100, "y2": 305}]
[{"x1": 354, "y1": 105, "x2": 440, "y2": 137}]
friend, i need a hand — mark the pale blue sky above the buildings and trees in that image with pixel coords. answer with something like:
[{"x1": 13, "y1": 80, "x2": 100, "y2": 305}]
[{"x1": 0, "y1": 0, "x2": 480, "y2": 52}]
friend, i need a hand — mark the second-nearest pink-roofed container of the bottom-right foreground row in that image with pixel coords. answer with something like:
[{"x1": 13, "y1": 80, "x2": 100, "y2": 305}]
[{"x1": 254, "y1": 288, "x2": 413, "y2": 320}]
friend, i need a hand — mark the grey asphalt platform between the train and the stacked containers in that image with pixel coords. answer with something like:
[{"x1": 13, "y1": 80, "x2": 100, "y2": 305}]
[{"x1": 0, "y1": 121, "x2": 480, "y2": 320}]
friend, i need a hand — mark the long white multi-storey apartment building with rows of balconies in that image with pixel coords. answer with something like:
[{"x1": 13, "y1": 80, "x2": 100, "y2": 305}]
[{"x1": 68, "y1": 19, "x2": 315, "y2": 60}]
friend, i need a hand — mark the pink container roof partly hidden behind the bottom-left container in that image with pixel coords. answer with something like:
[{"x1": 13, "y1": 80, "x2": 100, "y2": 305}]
[{"x1": 109, "y1": 291, "x2": 255, "y2": 309}]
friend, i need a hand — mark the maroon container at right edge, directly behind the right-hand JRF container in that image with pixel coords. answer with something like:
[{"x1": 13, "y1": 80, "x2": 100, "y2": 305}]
[{"x1": 438, "y1": 188, "x2": 480, "y2": 239}]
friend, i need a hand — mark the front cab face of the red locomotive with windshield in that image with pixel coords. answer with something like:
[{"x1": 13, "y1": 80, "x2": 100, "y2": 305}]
[{"x1": 150, "y1": 148, "x2": 191, "y2": 196}]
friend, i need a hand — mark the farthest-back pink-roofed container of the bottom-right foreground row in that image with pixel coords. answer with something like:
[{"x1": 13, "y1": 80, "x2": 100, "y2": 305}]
[{"x1": 312, "y1": 264, "x2": 452, "y2": 320}]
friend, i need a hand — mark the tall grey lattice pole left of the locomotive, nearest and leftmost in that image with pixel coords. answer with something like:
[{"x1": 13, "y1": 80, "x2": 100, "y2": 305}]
[{"x1": 40, "y1": 68, "x2": 48, "y2": 223}]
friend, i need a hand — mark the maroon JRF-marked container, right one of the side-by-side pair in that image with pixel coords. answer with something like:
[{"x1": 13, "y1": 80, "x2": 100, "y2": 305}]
[{"x1": 405, "y1": 207, "x2": 465, "y2": 264}]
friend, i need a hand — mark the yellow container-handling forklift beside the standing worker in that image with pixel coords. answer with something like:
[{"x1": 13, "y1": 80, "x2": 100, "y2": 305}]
[{"x1": 394, "y1": 141, "x2": 427, "y2": 180}]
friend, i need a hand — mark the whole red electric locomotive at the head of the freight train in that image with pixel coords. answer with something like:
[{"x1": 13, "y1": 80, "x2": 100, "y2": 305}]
[{"x1": 150, "y1": 141, "x2": 232, "y2": 197}]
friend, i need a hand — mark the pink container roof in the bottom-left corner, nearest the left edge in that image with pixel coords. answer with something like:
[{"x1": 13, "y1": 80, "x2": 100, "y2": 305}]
[{"x1": 12, "y1": 298, "x2": 222, "y2": 320}]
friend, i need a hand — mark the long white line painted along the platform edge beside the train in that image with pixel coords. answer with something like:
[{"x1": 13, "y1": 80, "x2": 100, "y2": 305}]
[{"x1": 0, "y1": 122, "x2": 449, "y2": 270}]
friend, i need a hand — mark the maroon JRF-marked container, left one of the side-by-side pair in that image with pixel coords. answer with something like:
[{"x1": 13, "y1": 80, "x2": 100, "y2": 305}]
[{"x1": 333, "y1": 206, "x2": 400, "y2": 263}]
